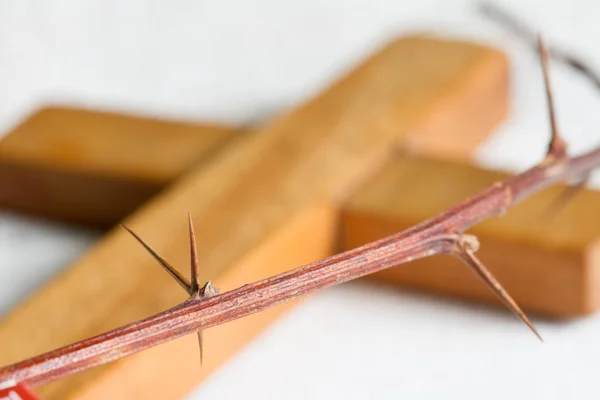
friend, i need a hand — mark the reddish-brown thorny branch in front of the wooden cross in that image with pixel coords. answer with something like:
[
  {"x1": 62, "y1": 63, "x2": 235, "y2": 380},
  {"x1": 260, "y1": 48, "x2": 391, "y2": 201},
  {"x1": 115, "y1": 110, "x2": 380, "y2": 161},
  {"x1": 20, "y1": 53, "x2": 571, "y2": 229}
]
[{"x1": 0, "y1": 36, "x2": 600, "y2": 387}]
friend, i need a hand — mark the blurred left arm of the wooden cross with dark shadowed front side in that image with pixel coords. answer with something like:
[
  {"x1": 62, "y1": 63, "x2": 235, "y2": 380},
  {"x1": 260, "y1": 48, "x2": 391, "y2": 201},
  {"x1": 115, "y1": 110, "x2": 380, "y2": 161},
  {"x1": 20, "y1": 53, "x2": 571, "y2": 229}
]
[{"x1": 0, "y1": 106, "x2": 241, "y2": 228}]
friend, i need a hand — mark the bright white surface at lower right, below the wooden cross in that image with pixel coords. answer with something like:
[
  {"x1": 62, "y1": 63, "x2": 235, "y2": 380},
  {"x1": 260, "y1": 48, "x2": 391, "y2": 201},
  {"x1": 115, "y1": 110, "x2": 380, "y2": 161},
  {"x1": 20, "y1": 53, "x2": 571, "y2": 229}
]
[{"x1": 189, "y1": 283, "x2": 600, "y2": 399}]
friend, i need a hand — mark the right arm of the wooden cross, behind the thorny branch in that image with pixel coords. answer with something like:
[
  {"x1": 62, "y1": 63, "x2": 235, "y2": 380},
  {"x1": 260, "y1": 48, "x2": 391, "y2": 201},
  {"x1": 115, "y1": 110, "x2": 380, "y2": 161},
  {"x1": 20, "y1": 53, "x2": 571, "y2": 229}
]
[{"x1": 340, "y1": 156, "x2": 600, "y2": 318}]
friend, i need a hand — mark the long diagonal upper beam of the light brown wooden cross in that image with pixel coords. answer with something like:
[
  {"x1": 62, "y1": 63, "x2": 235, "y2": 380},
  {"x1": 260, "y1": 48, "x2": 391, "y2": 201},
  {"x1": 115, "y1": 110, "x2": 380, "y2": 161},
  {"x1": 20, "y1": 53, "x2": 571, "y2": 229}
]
[{"x1": 0, "y1": 36, "x2": 507, "y2": 399}]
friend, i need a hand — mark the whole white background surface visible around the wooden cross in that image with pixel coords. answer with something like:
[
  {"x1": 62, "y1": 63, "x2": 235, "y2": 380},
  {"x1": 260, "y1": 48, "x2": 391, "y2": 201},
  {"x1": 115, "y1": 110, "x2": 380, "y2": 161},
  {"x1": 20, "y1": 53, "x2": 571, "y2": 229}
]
[{"x1": 0, "y1": 0, "x2": 600, "y2": 400}]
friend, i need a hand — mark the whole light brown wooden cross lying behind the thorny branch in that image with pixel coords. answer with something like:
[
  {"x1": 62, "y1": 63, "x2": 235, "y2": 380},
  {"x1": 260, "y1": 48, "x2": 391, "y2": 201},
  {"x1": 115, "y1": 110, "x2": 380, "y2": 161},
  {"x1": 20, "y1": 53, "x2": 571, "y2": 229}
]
[{"x1": 0, "y1": 36, "x2": 600, "y2": 399}]
